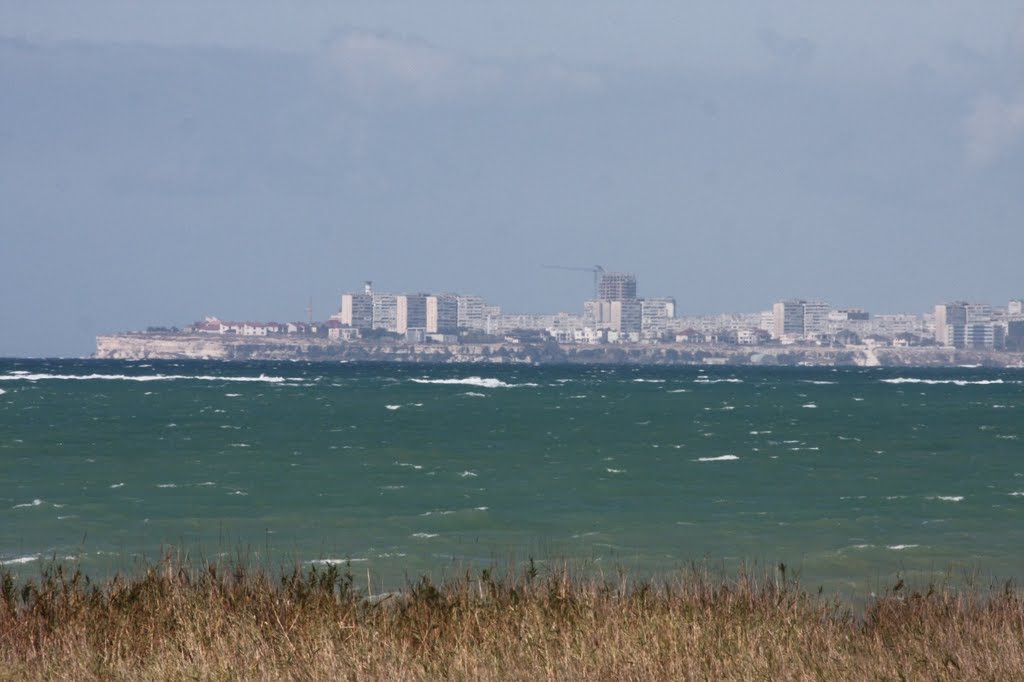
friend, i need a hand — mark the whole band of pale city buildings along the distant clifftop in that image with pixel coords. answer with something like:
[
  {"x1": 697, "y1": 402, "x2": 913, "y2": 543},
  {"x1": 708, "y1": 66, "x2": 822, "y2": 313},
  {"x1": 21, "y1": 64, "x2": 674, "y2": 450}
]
[{"x1": 187, "y1": 268, "x2": 1024, "y2": 350}]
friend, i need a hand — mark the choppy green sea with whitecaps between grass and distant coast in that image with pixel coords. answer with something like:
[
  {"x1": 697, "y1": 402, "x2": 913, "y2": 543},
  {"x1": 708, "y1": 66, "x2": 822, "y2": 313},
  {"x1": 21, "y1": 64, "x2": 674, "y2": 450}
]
[{"x1": 0, "y1": 359, "x2": 1024, "y2": 597}]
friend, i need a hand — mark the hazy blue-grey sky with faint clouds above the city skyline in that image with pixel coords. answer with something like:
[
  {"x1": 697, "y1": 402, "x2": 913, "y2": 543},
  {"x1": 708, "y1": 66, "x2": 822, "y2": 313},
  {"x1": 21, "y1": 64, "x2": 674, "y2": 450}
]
[{"x1": 0, "y1": 0, "x2": 1024, "y2": 356}]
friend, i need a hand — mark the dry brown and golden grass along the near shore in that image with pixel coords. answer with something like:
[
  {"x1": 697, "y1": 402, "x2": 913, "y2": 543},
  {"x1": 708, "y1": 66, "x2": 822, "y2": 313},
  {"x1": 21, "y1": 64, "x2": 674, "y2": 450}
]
[{"x1": 0, "y1": 560, "x2": 1024, "y2": 680}]
